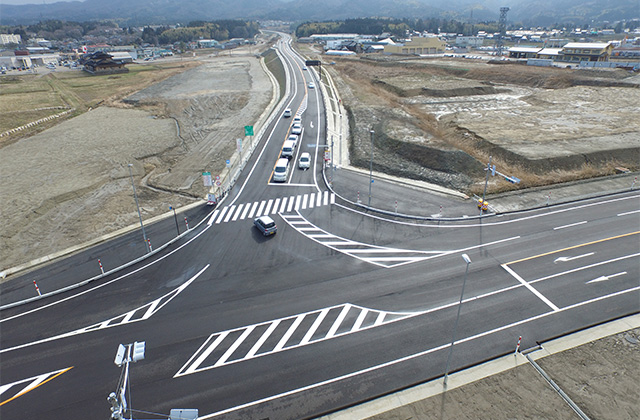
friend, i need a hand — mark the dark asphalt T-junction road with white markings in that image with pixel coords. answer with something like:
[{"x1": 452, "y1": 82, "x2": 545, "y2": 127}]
[{"x1": 0, "y1": 37, "x2": 640, "y2": 419}]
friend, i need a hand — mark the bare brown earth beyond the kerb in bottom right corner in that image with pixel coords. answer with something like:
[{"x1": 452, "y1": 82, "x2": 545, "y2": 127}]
[{"x1": 368, "y1": 329, "x2": 640, "y2": 420}]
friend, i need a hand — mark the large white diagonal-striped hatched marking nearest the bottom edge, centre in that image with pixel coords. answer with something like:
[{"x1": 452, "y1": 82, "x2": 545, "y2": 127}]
[{"x1": 174, "y1": 303, "x2": 426, "y2": 378}]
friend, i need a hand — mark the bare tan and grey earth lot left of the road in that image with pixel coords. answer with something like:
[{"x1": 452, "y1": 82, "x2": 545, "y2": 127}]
[{"x1": 0, "y1": 50, "x2": 272, "y2": 271}]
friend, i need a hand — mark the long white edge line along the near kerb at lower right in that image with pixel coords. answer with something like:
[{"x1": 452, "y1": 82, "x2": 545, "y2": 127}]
[{"x1": 199, "y1": 286, "x2": 640, "y2": 420}]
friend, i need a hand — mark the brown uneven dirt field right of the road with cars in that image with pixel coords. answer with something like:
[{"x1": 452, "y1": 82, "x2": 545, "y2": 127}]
[{"x1": 318, "y1": 51, "x2": 640, "y2": 193}]
